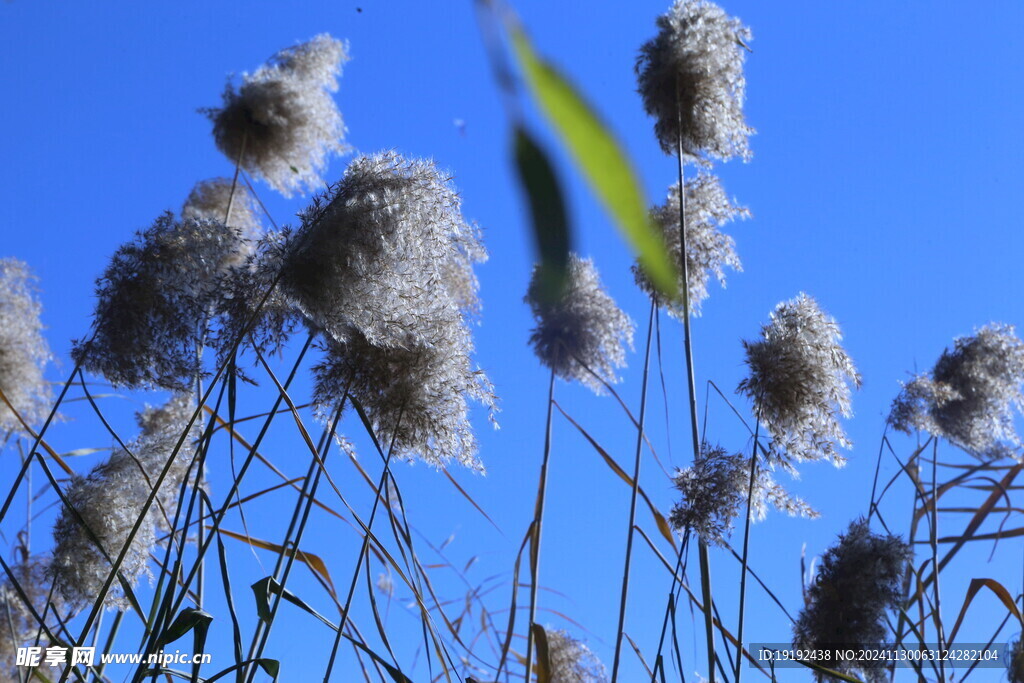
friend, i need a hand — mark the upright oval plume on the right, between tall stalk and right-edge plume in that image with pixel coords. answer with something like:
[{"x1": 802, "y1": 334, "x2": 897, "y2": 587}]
[{"x1": 737, "y1": 293, "x2": 860, "y2": 472}]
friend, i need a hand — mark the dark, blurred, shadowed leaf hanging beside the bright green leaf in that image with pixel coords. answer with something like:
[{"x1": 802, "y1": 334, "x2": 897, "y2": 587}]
[{"x1": 513, "y1": 126, "x2": 571, "y2": 302}]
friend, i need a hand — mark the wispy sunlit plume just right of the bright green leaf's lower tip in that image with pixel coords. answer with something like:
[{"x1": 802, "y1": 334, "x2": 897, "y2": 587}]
[{"x1": 633, "y1": 173, "x2": 751, "y2": 319}]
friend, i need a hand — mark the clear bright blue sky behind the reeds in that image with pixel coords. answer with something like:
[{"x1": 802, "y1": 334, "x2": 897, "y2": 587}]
[{"x1": 0, "y1": 0, "x2": 1024, "y2": 680}]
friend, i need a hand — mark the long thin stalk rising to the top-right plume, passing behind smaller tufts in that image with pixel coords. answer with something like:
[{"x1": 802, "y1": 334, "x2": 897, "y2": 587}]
[{"x1": 676, "y1": 79, "x2": 716, "y2": 683}]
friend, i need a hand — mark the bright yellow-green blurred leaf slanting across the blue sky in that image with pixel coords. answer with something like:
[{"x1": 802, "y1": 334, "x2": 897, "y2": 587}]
[{"x1": 510, "y1": 26, "x2": 678, "y2": 298}]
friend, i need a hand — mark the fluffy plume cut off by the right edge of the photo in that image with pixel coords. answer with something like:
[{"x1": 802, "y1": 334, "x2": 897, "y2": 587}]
[{"x1": 889, "y1": 323, "x2": 1024, "y2": 461}]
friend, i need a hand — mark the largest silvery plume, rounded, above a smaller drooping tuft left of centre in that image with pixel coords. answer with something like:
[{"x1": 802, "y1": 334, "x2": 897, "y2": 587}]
[{"x1": 282, "y1": 152, "x2": 486, "y2": 347}]
